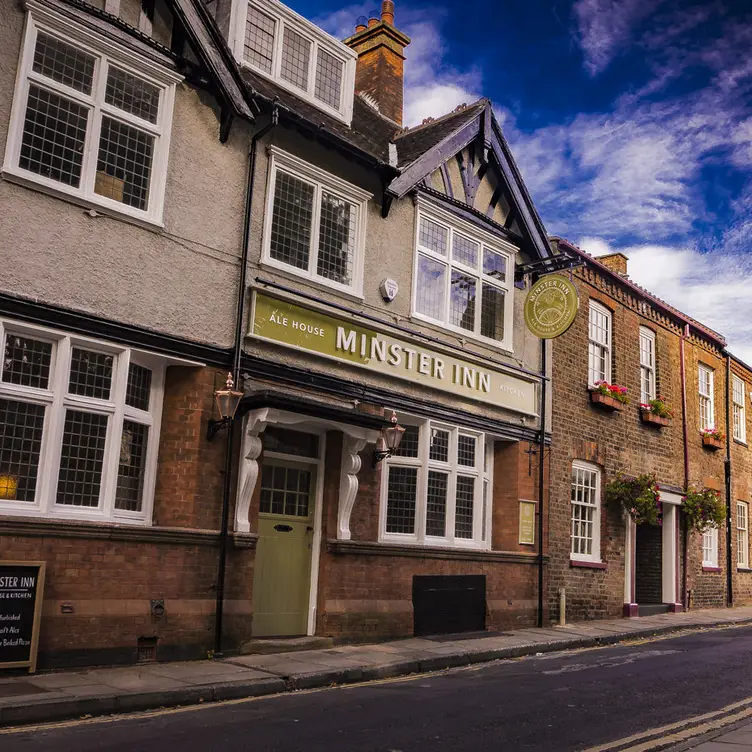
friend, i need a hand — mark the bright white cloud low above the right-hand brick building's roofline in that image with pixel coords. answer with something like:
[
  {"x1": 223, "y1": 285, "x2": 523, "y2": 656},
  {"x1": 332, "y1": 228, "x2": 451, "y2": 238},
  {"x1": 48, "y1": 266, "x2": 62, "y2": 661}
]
[{"x1": 578, "y1": 237, "x2": 752, "y2": 363}]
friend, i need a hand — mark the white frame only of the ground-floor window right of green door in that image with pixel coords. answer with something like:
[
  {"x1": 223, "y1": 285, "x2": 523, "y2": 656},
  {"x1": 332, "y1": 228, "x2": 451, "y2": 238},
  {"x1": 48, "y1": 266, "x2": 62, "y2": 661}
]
[{"x1": 379, "y1": 419, "x2": 493, "y2": 550}]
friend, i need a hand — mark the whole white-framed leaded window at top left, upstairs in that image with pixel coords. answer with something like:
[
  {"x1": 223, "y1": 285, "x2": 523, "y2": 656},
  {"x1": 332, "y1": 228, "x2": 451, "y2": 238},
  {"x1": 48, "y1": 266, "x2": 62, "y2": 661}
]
[{"x1": 3, "y1": 2, "x2": 181, "y2": 224}]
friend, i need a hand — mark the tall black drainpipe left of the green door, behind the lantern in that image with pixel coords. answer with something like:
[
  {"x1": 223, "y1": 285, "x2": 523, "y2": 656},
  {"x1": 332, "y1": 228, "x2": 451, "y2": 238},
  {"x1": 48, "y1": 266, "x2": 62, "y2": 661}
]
[{"x1": 214, "y1": 104, "x2": 279, "y2": 658}]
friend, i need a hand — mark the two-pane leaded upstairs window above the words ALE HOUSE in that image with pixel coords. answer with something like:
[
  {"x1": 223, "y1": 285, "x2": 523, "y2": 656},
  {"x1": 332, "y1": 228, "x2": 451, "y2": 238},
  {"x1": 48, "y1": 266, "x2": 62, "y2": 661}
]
[{"x1": 263, "y1": 149, "x2": 370, "y2": 295}]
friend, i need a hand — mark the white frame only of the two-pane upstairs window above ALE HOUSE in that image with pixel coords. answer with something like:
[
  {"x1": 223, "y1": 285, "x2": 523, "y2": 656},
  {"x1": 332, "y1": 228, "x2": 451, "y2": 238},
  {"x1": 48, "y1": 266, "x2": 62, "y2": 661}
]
[{"x1": 261, "y1": 146, "x2": 373, "y2": 298}]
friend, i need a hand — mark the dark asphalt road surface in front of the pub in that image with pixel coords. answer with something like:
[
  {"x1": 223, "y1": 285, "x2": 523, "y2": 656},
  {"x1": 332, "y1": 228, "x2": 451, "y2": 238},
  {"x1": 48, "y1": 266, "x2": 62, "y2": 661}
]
[{"x1": 8, "y1": 627, "x2": 752, "y2": 752}]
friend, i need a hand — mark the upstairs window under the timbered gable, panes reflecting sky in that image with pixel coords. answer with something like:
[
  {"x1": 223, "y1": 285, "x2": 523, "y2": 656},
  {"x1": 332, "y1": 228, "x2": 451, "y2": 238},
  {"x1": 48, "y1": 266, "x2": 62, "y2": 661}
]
[{"x1": 413, "y1": 209, "x2": 514, "y2": 350}]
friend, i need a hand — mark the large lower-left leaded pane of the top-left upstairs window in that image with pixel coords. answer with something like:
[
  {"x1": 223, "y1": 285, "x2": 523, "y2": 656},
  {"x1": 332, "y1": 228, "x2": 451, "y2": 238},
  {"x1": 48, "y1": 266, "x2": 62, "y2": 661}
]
[{"x1": 18, "y1": 84, "x2": 89, "y2": 188}]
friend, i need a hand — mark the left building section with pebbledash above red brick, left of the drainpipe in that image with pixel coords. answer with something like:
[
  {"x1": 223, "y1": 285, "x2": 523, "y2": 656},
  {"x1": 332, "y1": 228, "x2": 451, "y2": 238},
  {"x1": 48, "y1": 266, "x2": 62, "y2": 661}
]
[{"x1": 0, "y1": 0, "x2": 253, "y2": 667}]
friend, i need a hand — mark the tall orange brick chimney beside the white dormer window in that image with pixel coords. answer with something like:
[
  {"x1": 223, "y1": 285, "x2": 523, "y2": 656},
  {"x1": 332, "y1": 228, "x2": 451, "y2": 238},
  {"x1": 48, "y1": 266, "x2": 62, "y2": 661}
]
[{"x1": 345, "y1": 0, "x2": 410, "y2": 125}]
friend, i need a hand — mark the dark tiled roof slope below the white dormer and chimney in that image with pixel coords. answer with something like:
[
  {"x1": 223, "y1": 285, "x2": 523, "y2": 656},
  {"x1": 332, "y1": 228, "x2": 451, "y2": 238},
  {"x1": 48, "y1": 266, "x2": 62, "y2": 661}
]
[{"x1": 241, "y1": 66, "x2": 399, "y2": 165}]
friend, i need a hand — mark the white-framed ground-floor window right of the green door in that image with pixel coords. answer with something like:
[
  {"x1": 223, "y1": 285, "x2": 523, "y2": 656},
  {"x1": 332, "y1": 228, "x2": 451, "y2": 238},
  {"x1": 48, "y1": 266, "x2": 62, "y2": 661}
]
[{"x1": 381, "y1": 421, "x2": 493, "y2": 548}]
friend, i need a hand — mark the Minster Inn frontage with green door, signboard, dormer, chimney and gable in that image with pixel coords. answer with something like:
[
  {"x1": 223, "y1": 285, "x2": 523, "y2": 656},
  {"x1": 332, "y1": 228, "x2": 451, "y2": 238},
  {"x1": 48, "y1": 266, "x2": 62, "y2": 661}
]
[{"x1": 203, "y1": 0, "x2": 551, "y2": 643}]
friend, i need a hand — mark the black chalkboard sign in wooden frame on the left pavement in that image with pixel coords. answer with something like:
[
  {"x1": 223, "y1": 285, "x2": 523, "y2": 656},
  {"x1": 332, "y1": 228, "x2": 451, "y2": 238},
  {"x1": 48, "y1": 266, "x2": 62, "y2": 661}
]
[{"x1": 0, "y1": 561, "x2": 45, "y2": 673}]
